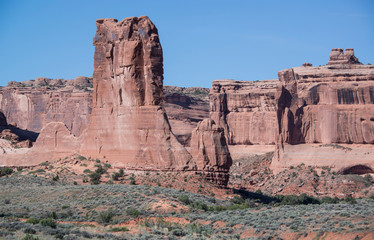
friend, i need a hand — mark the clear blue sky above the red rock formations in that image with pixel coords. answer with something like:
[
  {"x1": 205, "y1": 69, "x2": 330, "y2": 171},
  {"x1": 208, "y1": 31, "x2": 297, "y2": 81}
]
[{"x1": 0, "y1": 0, "x2": 374, "y2": 87}]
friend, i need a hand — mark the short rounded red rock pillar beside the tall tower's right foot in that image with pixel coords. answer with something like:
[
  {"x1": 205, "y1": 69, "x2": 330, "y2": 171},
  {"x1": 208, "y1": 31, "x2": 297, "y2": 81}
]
[{"x1": 191, "y1": 119, "x2": 232, "y2": 185}]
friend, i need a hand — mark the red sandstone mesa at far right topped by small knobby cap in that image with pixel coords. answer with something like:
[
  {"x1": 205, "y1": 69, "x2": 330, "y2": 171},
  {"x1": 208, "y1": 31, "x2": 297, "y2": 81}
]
[{"x1": 272, "y1": 49, "x2": 374, "y2": 172}]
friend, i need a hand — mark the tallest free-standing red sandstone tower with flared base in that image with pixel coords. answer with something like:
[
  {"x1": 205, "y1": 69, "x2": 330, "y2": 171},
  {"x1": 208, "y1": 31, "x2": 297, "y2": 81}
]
[{"x1": 81, "y1": 17, "x2": 192, "y2": 170}]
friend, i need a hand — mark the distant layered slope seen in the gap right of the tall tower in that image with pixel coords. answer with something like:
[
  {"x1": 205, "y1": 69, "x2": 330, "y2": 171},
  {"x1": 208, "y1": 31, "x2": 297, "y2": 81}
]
[{"x1": 163, "y1": 86, "x2": 209, "y2": 147}]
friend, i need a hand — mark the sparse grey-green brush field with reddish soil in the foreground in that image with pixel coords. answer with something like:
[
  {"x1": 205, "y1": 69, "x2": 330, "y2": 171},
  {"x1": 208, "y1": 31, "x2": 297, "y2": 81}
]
[{"x1": 0, "y1": 172, "x2": 374, "y2": 239}]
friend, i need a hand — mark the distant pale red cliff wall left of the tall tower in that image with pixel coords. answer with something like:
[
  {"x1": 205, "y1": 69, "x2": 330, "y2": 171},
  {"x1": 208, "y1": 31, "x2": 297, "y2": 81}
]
[{"x1": 0, "y1": 77, "x2": 92, "y2": 136}]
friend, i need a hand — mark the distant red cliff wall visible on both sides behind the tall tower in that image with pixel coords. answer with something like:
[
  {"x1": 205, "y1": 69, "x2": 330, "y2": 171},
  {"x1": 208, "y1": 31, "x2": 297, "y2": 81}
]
[{"x1": 0, "y1": 79, "x2": 209, "y2": 146}]
